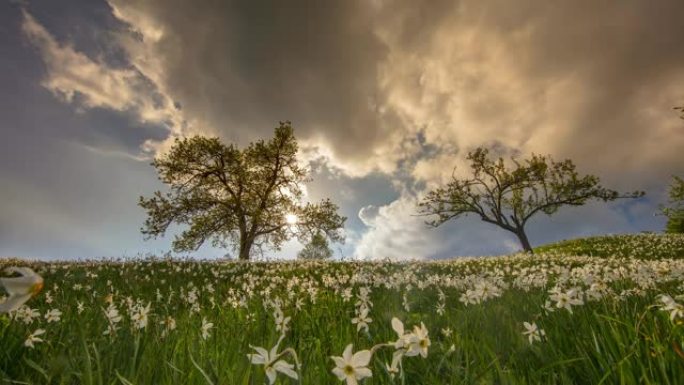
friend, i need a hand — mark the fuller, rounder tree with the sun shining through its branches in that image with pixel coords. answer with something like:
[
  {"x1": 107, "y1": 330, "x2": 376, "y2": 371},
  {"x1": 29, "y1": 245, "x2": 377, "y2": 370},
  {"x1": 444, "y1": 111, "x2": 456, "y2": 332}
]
[{"x1": 139, "y1": 122, "x2": 346, "y2": 260}]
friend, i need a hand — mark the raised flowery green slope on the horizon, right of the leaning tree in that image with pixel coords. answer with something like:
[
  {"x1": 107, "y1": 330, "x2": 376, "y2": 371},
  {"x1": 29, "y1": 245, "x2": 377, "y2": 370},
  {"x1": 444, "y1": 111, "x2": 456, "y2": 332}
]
[{"x1": 534, "y1": 233, "x2": 684, "y2": 259}]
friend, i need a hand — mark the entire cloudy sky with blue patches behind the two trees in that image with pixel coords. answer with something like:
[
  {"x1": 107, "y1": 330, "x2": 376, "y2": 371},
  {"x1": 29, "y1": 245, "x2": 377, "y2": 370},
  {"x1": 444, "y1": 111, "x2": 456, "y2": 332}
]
[{"x1": 0, "y1": 0, "x2": 684, "y2": 259}]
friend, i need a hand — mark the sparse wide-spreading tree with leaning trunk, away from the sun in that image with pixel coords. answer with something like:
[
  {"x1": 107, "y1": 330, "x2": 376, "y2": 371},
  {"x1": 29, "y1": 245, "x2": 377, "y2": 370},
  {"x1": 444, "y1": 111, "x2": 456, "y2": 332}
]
[{"x1": 419, "y1": 148, "x2": 644, "y2": 253}]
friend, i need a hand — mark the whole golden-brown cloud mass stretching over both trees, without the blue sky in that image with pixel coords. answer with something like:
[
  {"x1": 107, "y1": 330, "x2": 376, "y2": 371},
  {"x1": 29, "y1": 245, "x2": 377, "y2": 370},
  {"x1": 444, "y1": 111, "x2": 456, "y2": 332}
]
[{"x1": 10, "y1": 0, "x2": 684, "y2": 257}]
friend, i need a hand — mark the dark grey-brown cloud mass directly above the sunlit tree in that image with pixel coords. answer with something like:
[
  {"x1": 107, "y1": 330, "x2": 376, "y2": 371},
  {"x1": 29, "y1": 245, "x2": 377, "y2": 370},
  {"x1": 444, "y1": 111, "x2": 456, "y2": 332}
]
[{"x1": 111, "y1": 1, "x2": 406, "y2": 171}]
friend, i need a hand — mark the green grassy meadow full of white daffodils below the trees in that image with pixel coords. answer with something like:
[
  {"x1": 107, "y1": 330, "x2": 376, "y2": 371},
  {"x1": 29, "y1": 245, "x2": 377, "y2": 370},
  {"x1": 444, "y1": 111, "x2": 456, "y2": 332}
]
[{"x1": 0, "y1": 231, "x2": 684, "y2": 385}]
